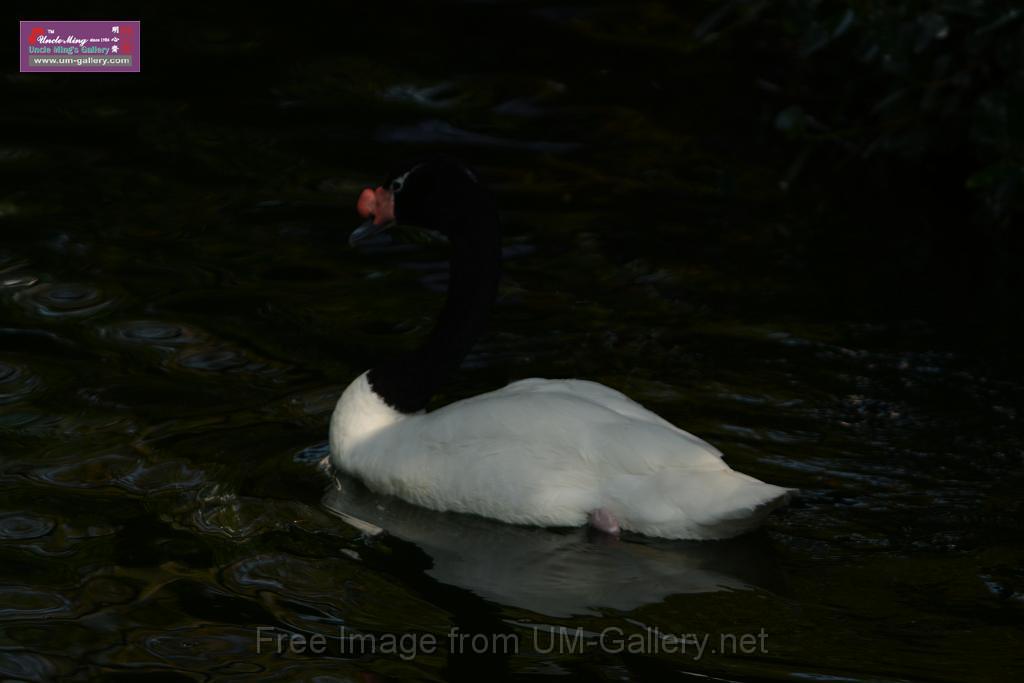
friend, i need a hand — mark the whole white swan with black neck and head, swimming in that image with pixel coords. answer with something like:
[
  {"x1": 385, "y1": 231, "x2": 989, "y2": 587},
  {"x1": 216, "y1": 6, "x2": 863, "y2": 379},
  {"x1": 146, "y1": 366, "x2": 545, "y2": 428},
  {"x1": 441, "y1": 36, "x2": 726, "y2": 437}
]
[{"x1": 330, "y1": 158, "x2": 788, "y2": 539}]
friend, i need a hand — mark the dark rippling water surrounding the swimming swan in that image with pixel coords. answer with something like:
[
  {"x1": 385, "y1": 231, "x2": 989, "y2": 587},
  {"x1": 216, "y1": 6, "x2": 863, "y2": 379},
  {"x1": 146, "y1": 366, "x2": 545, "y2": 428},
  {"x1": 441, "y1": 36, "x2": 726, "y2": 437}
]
[{"x1": 0, "y1": 3, "x2": 1024, "y2": 681}]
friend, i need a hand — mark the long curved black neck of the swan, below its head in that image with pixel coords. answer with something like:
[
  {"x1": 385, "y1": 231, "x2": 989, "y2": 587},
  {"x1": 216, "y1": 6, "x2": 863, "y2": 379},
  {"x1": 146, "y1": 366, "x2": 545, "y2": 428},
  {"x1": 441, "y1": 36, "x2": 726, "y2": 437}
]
[{"x1": 369, "y1": 203, "x2": 501, "y2": 413}]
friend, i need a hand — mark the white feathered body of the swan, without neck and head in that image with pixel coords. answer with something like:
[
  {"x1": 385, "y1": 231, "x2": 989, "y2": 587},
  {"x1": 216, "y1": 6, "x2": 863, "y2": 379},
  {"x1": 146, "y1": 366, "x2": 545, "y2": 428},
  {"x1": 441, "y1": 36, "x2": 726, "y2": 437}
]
[{"x1": 331, "y1": 373, "x2": 788, "y2": 539}]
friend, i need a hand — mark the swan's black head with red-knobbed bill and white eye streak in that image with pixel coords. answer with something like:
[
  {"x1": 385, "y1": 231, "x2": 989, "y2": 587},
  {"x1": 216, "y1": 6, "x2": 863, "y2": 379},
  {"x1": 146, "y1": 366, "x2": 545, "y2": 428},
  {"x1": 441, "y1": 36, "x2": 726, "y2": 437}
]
[{"x1": 349, "y1": 157, "x2": 495, "y2": 245}]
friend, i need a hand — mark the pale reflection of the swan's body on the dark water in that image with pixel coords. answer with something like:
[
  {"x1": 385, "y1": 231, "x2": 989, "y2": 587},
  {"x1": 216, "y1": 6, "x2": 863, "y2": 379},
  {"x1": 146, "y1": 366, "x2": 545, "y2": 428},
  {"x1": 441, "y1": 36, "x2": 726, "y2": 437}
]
[{"x1": 323, "y1": 476, "x2": 779, "y2": 617}]
